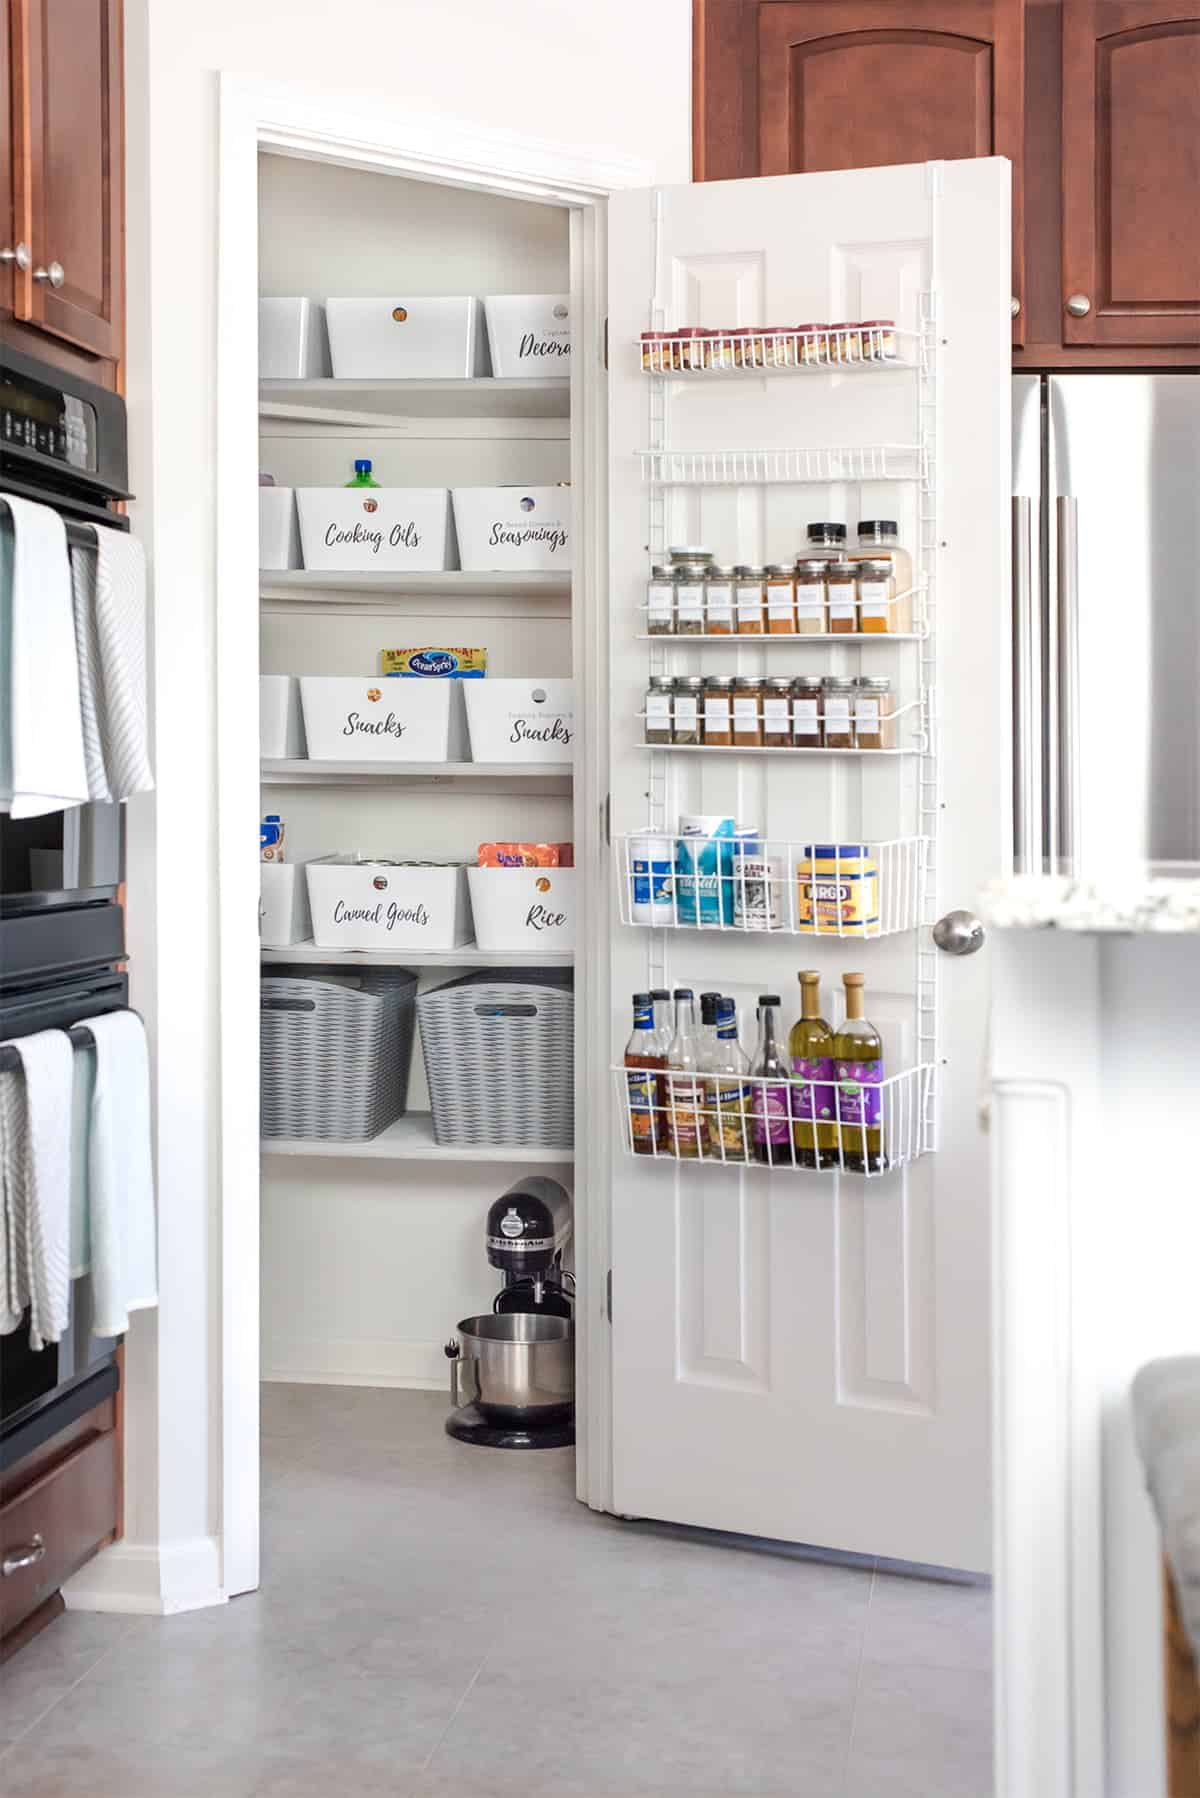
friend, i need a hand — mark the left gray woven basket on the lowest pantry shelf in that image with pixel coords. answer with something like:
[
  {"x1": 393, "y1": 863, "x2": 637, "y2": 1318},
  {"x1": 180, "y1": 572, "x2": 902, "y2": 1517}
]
[{"x1": 261, "y1": 969, "x2": 417, "y2": 1142}]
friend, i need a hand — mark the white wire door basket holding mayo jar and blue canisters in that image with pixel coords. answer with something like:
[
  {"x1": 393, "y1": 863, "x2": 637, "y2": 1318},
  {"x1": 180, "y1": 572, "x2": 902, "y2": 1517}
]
[{"x1": 613, "y1": 831, "x2": 928, "y2": 942}]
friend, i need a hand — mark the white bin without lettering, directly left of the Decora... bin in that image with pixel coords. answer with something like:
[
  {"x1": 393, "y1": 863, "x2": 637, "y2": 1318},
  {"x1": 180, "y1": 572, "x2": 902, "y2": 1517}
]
[{"x1": 326, "y1": 295, "x2": 488, "y2": 381}]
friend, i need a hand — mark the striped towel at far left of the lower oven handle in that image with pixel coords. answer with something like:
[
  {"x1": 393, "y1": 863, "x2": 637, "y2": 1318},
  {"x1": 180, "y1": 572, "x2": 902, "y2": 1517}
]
[{"x1": 0, "y1": 1030, "x2": 76, "y2": 1349}]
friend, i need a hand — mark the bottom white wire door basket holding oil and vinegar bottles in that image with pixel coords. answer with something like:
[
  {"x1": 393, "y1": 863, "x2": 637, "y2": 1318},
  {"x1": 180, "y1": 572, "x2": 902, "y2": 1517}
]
[{"x1": 612, "y1": 1063, "x2": 936, "y2": 1179}]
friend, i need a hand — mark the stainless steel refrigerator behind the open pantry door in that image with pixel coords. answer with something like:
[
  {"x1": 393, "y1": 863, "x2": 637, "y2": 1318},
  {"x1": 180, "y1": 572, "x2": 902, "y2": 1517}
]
[{"x1": 1013, "y1": 374, "x2": 1200, "y2": 877}]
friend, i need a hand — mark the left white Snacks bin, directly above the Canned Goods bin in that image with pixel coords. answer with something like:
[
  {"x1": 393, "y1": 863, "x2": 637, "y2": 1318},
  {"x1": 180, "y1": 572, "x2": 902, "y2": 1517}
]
[{"x1": 300, "y1": 674, "x2": 468, "y2": 762}]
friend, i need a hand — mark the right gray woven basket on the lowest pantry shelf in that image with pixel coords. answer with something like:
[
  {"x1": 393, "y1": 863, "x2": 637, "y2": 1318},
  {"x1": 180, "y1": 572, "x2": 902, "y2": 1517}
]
[{"x1": 417, "y1": 967, "x2": 576, "y2": 1149}]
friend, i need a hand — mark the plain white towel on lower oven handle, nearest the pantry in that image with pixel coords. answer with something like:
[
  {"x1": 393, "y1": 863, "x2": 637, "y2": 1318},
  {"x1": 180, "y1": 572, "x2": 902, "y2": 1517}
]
[{"x1": 88, "y1": 1012, "x2": 158, "y2": 1336}]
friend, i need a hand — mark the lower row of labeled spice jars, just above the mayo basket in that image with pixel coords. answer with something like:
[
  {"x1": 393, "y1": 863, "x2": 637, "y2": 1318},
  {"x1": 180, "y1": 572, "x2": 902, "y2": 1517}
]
[{"x1": 644, "y1": 674, "x2": 896, "y2": 750}]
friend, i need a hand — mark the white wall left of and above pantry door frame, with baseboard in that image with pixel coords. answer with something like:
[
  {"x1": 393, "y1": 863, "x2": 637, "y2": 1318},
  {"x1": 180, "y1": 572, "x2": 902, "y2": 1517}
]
[{"x1": 103, "y1": 0, "x2": 691, "y2": 1609}]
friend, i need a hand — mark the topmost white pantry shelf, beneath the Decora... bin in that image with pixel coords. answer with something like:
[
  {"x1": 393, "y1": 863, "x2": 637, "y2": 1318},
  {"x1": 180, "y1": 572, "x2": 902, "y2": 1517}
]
[{"x1": 259, "y1": 374, "x2": 570, "y2": 424}]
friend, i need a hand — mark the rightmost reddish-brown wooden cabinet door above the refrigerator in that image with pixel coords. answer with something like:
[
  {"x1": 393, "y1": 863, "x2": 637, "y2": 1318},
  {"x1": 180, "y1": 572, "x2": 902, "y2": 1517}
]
[{"x1": 1063, "y1": 0, "x2": 1200, "y2": 347}]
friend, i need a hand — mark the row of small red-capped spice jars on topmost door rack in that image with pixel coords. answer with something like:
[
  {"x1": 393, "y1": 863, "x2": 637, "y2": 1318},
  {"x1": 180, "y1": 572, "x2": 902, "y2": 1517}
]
[{"x1": 640, "y1": 318, "x2": 900, "y2": 374}]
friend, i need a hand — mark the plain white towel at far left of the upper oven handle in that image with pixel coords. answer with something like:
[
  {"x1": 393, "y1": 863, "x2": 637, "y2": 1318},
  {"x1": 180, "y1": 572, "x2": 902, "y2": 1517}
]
[{"x1": 0, "y1": 493, "x2": 88, "y2": 818}]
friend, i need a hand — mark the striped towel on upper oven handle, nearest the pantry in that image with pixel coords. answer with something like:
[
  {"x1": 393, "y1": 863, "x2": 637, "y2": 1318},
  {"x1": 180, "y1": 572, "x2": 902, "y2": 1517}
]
[{"x1": 70, "y1": 525, "x2": 155, "y2": 800}]
